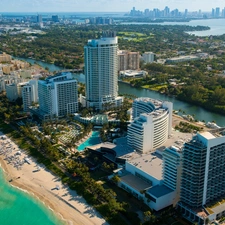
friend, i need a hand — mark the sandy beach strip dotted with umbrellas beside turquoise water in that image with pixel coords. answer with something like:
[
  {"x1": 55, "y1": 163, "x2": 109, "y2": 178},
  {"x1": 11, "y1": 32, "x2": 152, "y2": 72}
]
[{"x1": 0, "y1": 133, "x2": 108, "y2": 225}]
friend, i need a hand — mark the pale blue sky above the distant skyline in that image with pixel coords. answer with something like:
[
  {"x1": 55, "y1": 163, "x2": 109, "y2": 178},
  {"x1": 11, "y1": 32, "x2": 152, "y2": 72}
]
[{"x1": 0, "y1": 0, "x2": 225, "y2": 13}]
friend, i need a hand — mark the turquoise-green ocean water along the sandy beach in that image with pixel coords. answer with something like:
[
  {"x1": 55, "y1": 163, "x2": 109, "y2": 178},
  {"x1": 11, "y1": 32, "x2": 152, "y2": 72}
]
[{"x1": 0, "y1": 168, "x2": 63, "y2": 225}]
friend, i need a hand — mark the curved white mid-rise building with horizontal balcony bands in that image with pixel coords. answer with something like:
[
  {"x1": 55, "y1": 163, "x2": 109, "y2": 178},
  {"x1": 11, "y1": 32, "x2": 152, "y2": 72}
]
[{"x1": 127, "y1": 99, "x2": 173, "y2": 153}]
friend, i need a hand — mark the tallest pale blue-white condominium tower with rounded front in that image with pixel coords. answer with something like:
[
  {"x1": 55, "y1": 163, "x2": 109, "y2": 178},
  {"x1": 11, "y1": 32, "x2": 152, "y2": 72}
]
[{"x1": 84, "y1": 32, "x2": 122, "y2": 109}]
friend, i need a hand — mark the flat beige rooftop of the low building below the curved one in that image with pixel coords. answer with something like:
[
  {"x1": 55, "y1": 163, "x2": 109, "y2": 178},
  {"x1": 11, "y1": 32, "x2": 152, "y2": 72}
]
[{"x1": 127, "y1": 152, "x2": 163, "y2": 180}]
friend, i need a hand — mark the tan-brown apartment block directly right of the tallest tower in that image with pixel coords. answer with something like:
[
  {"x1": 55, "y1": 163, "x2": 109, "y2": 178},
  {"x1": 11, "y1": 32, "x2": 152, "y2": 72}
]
[{"x1": 117, "y1": 50, "x2": 140, "y2": 71}]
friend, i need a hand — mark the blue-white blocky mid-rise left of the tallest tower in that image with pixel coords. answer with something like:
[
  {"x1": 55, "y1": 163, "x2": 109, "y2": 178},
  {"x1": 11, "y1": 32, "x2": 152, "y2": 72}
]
[{"x1": 38, "y1": 73, "x2": 78, "y2": 118}]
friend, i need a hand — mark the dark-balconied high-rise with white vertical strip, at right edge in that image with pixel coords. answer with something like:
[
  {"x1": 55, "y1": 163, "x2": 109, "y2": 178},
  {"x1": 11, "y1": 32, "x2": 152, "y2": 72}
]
[{"x1": 178, "y1": 131, "x2": 225, "y2": 224}]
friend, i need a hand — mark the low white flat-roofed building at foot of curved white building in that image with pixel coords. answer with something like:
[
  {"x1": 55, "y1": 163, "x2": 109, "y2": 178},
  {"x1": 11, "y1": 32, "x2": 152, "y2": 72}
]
[{"x1": 118, "y1": 152, "x2": 176, "y2": 211}]
